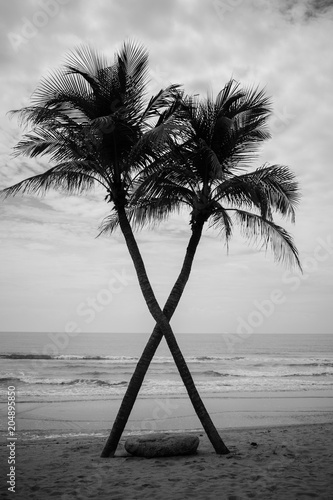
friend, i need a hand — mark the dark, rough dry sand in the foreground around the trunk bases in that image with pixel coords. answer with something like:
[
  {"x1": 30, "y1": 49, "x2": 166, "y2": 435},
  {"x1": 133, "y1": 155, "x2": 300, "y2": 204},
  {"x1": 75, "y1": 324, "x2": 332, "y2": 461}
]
[{"x1": 0, "y1": 423, "x2": 333, "y2": 500}]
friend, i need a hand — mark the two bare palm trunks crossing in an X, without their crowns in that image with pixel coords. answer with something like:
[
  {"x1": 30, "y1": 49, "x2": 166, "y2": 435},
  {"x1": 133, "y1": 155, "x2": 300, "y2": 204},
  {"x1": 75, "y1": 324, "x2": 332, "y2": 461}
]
[{"x1": 101, "y1": 211, "x2": 229, "y2": 457}]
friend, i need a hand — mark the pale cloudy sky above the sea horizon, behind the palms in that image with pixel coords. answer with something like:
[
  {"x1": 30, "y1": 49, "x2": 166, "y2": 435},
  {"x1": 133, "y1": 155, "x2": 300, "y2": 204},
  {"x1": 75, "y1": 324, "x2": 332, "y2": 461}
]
[{"x1": 0, "y1": 0, "x2": 333, "y2": 334}]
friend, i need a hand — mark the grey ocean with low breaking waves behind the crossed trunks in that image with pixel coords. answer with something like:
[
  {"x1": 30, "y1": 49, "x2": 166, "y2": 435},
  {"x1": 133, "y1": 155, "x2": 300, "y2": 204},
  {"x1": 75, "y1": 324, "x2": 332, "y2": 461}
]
[{"x1": 0, "y1": 332, "x2": 333, "y2": 402}]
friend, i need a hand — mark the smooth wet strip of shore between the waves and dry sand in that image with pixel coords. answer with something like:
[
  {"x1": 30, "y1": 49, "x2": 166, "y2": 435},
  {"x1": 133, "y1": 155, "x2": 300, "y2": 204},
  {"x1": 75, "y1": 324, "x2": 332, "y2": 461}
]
[{"x1": 0, "y1": 391, "x2": 333, "y2": 436}]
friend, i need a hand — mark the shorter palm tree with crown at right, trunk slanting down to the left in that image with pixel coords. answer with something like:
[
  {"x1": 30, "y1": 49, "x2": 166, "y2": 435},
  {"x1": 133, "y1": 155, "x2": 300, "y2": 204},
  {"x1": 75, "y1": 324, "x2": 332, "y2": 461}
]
[{"x1": 102, "y1": 80, "x2": 301, "y2": 456}]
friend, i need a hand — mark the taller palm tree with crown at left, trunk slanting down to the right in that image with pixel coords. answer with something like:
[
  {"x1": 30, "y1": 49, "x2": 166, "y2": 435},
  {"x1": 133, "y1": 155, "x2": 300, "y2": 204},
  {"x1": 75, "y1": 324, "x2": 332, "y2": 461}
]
[{"x1": 3, "y1": 43, "x2": 229, "y2": 453}]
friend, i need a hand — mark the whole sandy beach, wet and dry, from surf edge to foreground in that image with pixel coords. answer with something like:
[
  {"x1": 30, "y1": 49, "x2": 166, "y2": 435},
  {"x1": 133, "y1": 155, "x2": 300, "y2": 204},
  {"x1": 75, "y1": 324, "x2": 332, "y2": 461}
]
[{"x1": 0, "y1": 394, "x2": 333, "y2": 500}]
